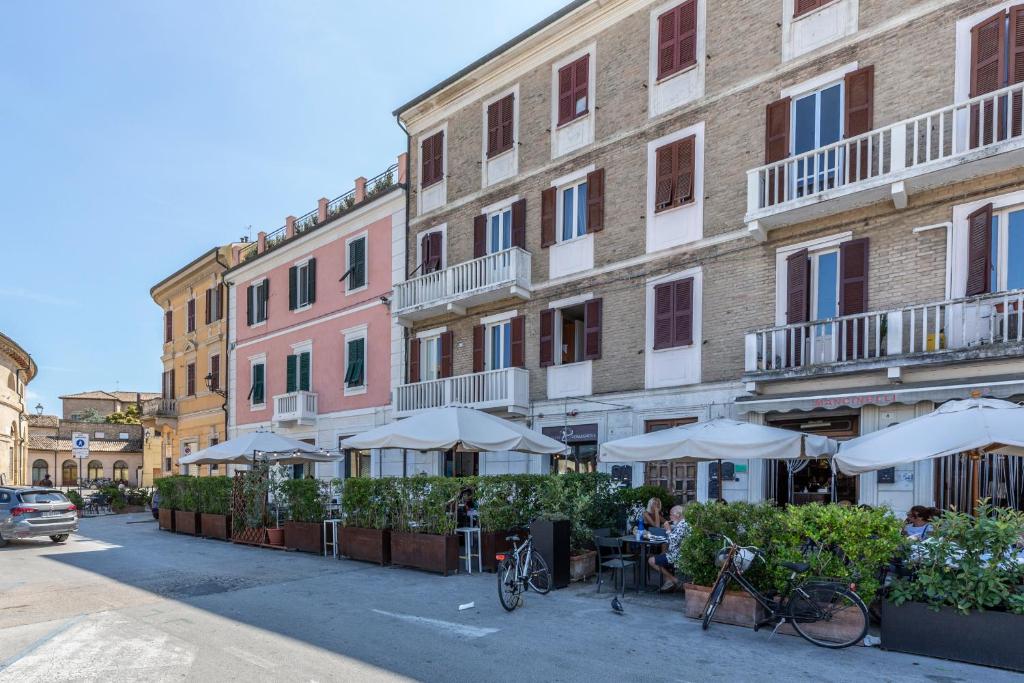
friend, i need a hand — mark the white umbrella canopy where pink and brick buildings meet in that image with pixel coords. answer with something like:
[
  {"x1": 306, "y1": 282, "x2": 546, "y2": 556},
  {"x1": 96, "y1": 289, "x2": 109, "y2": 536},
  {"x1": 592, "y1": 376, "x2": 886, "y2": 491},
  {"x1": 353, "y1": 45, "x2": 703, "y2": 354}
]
[{"x1": 341, "y1": 407, "x2": 568, "y2": 455}]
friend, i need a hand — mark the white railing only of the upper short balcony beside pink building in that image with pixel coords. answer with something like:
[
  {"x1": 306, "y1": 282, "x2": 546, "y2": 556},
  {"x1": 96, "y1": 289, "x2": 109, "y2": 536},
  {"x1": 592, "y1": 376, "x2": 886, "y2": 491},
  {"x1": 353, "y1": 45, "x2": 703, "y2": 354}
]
[{"x1": 394, "y1": 247, "x2": 530, "y2": 312}]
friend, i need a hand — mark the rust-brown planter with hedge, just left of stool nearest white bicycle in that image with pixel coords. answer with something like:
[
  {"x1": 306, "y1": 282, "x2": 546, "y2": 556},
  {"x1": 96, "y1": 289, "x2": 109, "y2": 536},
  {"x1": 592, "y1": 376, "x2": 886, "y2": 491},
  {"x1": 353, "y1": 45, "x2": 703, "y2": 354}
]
[{"x1": 389, "y1": 477, "x2": 466, "y2": 577}]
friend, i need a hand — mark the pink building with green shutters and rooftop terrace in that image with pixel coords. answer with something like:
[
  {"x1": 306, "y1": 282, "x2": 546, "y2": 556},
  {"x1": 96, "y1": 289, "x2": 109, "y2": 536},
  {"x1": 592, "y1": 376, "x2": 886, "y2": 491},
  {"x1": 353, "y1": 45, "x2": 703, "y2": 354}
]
[{"x1": 225, "y1": 155, "x2": 406, "y2": 476}]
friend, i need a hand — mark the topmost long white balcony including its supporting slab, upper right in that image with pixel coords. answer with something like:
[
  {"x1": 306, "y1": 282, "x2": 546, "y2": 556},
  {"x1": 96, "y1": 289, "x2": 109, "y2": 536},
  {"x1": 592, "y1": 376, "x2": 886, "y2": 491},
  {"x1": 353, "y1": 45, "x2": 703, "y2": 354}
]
[{"x1": 745, "y1": 84, "x2": 1024, "y2": 239}]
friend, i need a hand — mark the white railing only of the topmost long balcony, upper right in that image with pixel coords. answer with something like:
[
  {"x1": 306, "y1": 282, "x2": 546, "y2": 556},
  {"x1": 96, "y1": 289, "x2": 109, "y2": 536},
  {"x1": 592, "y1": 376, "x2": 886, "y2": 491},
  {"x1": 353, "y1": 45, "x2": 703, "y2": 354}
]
[{"x1": 746, "y1": 83, "x2": 1024, "y2": 214}]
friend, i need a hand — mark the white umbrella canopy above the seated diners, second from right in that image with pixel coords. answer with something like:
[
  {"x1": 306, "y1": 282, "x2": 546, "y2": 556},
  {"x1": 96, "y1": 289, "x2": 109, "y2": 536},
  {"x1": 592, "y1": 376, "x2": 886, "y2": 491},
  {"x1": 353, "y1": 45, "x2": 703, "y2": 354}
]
[{"x1": 600, "y1": 418, "x2": 837, "y2": 463}]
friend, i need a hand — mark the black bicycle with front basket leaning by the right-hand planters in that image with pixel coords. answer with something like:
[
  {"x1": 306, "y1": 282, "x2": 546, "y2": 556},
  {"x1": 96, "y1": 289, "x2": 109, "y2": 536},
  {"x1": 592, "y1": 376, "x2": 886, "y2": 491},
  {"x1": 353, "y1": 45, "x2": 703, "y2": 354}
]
[{"x1": 701, "y1": 533, "x2": 867, "y2": 649}]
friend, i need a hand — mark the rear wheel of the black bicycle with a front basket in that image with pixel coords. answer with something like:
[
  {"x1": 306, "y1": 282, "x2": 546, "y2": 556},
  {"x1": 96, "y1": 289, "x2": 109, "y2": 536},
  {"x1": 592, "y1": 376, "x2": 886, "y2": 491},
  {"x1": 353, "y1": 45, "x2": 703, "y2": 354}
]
[{"x1": 788, "y1": 584, "x2": 867, "y2": 649}]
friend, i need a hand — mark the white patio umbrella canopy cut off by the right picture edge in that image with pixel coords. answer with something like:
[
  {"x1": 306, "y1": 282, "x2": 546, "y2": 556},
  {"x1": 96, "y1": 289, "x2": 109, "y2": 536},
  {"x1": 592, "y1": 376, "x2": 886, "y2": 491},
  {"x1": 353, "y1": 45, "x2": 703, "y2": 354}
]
[{"x1": 835, "y1": 398, "x2": 1024, "y2": 474}]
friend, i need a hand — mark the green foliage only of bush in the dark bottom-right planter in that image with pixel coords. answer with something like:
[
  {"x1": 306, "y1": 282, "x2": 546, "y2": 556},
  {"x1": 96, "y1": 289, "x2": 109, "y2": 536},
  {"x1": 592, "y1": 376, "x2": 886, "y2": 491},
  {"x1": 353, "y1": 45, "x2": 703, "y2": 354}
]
[{"x1": 891, "y1": 501, "x2": 1024, "y2": 614}]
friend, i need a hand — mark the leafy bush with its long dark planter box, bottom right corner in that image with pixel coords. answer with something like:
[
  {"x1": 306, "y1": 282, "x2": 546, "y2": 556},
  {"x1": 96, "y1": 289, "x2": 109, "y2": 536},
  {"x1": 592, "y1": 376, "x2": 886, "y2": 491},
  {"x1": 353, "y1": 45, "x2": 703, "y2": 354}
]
[{"x1": 882, "y1": 501, "x2": 1024, "y2": 671}]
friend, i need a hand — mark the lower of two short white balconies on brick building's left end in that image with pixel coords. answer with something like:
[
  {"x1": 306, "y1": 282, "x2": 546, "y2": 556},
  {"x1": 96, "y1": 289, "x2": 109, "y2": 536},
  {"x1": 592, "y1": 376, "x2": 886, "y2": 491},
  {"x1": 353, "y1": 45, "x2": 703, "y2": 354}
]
[{"x1": 394, "y1": 368, "x2": 529, "y2": 417}]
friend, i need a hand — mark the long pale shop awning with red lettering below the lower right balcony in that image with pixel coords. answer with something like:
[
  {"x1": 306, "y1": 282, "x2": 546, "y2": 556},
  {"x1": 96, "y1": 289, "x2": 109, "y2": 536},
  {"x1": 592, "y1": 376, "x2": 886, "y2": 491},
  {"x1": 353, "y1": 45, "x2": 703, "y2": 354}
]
[{"x1": 736, "y1": 376, "x2": 1024, "y2": 415}]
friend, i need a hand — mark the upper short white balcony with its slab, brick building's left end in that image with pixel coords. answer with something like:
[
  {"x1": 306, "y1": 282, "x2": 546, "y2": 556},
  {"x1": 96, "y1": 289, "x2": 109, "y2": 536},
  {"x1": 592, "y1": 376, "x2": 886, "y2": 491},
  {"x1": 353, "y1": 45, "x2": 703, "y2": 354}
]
[{"x1": 392, "y1": 247, "x2": 532, "y2": 323}]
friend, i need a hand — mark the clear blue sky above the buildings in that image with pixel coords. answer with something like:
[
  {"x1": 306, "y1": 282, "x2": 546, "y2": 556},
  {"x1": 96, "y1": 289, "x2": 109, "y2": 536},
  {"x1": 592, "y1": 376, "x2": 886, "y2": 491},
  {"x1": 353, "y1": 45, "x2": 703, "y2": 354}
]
[{"x1": 0, "y1": 0, "x2": 566, "y2": 413}]
